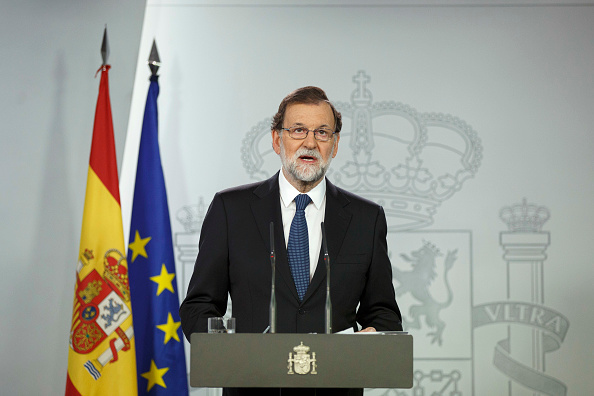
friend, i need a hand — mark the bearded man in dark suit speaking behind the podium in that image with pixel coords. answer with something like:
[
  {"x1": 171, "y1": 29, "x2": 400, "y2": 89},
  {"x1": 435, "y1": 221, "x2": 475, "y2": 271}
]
[{"x1": 180, "y1": 87, "x2": 402, "y2": 395}]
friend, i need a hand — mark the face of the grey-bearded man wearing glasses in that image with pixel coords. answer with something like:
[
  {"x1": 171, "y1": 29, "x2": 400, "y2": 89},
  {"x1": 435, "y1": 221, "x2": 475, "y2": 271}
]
[{"x1": 272, "y1": 102, "x2": 340, "y2": 189}]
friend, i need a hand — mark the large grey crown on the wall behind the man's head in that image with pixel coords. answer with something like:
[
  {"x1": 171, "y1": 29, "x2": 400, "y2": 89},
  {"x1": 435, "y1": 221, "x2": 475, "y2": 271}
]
[{"x1": 241, "y1": 71, "x2": 482, "y2": 231}]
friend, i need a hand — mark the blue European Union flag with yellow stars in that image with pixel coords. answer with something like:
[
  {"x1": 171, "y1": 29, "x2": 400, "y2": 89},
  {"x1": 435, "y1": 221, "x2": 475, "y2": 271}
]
[{"x1": 128, "y1": 75, "x2": 188, "y2": 395}]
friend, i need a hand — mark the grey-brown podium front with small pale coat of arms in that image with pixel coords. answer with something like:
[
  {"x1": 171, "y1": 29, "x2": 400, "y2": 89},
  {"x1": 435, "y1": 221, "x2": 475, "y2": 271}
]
[{"x1": 190, "y1": 333, "x2": 413, "y2": 388}]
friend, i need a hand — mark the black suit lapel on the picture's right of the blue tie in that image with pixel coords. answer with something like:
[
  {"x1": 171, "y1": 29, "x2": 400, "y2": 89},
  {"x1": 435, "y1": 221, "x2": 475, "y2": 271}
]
[{"x1": 303, "y1": 179, "x2": 352, "y2": 301}]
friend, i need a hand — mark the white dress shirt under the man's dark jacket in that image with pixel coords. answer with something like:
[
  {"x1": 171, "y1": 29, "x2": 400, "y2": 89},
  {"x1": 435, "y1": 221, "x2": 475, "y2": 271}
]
[{"x1": 278, "y1": 169, "x2": 326, "y2": 281}]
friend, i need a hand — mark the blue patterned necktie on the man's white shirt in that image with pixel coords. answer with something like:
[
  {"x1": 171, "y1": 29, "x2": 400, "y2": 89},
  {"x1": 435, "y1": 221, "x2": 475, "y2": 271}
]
[{"x1": 287, "y1": 194, "x2": 311, "y2": 301}]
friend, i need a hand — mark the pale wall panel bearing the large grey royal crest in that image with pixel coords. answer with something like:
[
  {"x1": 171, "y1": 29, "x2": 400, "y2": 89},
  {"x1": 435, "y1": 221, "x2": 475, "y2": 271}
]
[{"x1": 121, "y1": 0, "x2": 594, "y2": 395}]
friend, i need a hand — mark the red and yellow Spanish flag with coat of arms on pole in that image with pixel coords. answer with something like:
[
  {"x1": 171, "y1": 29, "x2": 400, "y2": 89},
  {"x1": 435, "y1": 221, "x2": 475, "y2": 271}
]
[{"x1": 66, "y1": 65, "x2": 137, "y2": 396}]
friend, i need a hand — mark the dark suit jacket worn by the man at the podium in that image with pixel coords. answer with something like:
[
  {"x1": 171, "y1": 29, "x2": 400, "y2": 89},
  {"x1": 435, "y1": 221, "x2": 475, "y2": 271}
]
[{"x1": 180, "y1": 173, "x2": 402, "y2": 339}]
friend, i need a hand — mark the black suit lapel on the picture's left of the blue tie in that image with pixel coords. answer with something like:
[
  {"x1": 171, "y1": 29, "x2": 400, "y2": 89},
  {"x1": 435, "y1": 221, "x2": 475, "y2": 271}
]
[{"x1": 251, "y1": 172, "x2": 299, "y2": 300}]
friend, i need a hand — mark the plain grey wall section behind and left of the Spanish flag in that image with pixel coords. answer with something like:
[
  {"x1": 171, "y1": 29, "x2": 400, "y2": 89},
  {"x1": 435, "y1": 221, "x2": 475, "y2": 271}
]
[{"x1": 0, "y1": 0, "x2": 145, "y2": 395}]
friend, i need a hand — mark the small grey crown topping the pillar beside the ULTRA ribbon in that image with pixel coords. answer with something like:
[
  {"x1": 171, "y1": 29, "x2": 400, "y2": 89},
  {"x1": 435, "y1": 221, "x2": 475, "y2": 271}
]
[{"x1": 499, "y1": 198, "x2": 551, "y2": 232}]
